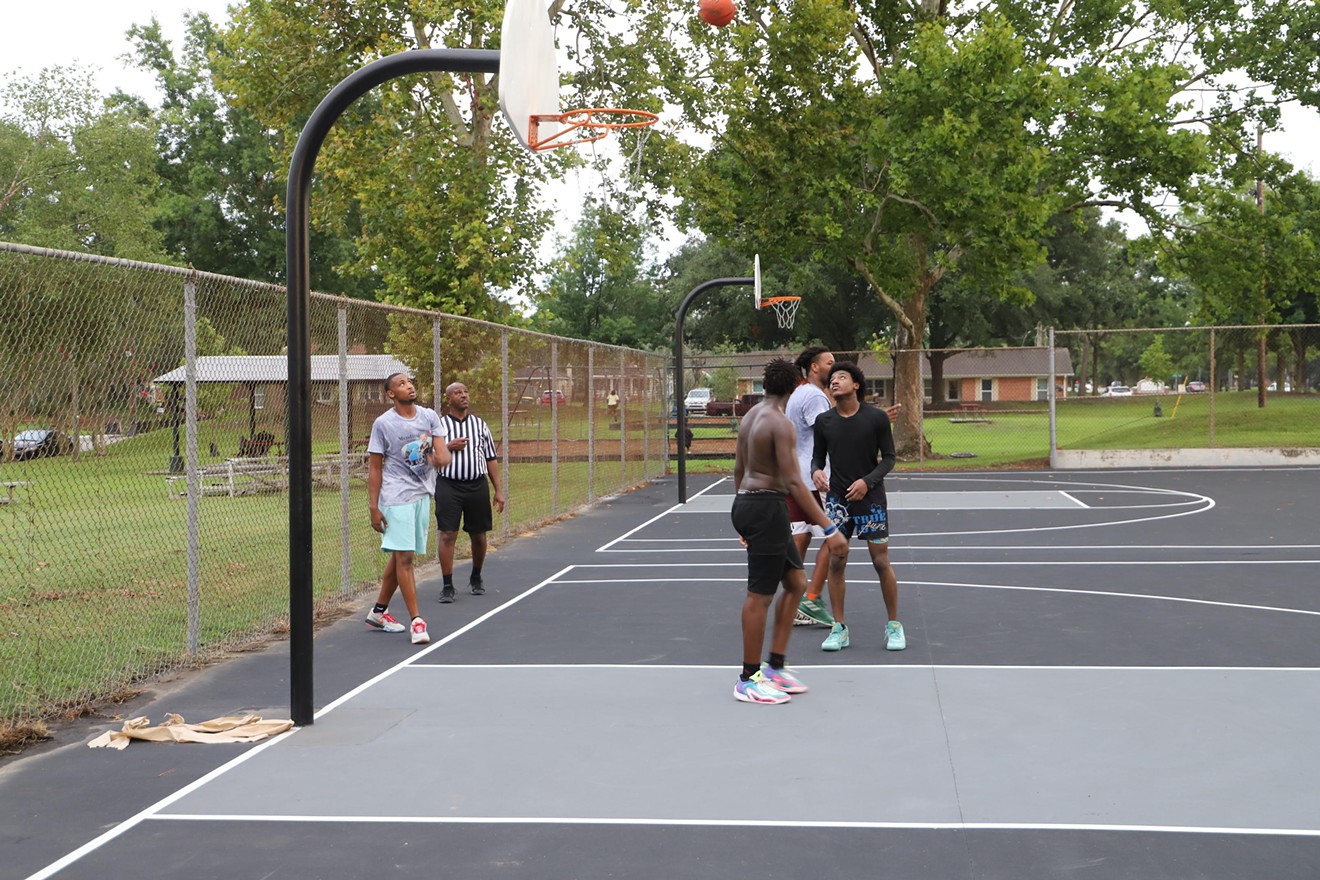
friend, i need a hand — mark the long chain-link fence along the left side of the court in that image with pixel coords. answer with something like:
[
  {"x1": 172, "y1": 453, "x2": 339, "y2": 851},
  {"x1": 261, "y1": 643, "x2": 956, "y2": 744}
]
[{"x1": 0, "y1": 238, "x2": 669, "y2": 728}]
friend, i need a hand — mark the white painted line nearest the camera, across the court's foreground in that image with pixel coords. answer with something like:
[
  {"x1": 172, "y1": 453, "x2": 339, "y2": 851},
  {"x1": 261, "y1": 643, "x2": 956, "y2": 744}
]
[{"x1": 141, "y1": 813, "x2": 1320, "y2": 838}]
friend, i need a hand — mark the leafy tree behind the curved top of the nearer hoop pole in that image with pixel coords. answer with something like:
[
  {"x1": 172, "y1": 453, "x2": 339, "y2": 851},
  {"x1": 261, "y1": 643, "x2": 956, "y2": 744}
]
[{"x1": 213, "y1": 0, "x2": 566, "y2": 319}]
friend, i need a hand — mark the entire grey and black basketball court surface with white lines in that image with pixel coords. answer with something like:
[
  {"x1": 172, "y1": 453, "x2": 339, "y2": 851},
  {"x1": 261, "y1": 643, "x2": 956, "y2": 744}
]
[{"x1": 0, "y1": 468, "x2": 1320, "y2": 880}]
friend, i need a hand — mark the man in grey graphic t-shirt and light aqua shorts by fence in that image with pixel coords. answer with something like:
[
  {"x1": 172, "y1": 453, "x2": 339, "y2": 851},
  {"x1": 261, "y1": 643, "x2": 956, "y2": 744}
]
[{"x1": 367, "y1": 373, "x2": 450, "y2": 645}]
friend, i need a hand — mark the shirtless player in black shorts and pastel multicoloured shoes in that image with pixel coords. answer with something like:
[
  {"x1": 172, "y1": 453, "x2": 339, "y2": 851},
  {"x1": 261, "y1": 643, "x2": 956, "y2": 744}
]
[{"x1": 731, "y1": 358, "x2": 847, "y2": 703}]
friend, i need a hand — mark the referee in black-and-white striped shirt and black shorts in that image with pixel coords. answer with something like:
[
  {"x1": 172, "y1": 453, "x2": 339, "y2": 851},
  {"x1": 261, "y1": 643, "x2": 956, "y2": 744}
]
[{"x1": 436, "y1": 383, "x2": 504, "y2": 604}]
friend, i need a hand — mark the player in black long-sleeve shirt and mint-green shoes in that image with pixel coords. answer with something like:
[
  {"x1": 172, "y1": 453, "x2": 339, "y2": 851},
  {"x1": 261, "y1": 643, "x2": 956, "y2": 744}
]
[{"x1": 812, "y1": 360, "x2": 907, "y2": 650}]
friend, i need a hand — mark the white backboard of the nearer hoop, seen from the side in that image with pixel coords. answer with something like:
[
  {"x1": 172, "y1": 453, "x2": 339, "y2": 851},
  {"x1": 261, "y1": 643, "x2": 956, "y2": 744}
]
[{"x1": 499, "y1": 0, "x2": 562, "y2": 149}]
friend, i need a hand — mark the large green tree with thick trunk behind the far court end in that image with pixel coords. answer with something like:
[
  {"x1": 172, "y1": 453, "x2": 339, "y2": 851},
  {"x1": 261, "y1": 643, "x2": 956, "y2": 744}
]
[{"x1": 573, "y1": 0, "x2": 1313, "y2": 453}]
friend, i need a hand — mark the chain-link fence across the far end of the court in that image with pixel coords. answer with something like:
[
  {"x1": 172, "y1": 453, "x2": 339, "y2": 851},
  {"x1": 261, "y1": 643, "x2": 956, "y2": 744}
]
[{"x1": 684, "y1": 337, "x2": 1320, "y2": 470}]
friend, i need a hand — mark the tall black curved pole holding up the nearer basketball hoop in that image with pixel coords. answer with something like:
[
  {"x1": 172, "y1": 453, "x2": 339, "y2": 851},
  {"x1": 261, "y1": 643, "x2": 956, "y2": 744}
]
[{"x1": 284, "y1": 49, "x2": 499, "y2": 727}]
